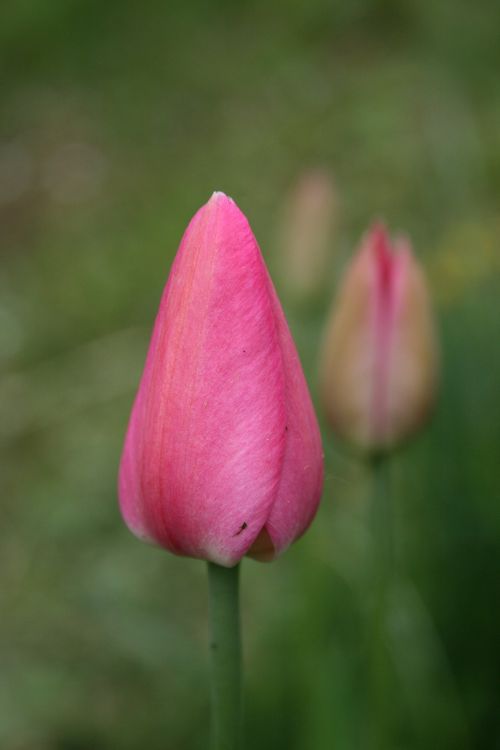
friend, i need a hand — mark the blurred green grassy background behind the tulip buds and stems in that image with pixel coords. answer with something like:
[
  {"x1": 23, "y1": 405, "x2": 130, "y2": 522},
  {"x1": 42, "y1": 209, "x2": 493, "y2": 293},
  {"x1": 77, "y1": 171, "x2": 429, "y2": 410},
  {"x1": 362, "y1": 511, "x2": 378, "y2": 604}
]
[{"x1": 0, "y1": 0, "x2": 500, "y2": 750}]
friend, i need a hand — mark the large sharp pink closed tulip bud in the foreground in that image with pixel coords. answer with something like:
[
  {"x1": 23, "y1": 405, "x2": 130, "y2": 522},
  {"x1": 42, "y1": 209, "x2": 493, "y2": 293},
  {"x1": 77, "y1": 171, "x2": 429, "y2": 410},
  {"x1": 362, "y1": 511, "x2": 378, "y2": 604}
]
[{"x1": 119, "y1": 193, "x2": 323, "y2": 567}]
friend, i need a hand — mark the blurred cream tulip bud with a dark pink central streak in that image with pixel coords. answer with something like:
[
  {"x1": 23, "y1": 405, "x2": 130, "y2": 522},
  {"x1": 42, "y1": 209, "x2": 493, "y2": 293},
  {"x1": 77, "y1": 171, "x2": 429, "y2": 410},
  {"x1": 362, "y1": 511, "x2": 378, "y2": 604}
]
[{"x1": 321, "y1": 225, "x2": 438, "y2": 452}]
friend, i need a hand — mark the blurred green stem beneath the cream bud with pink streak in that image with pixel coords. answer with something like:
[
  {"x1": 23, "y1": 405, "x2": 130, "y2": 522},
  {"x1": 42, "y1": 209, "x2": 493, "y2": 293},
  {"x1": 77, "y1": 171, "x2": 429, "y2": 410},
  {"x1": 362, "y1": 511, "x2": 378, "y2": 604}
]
[{"x1": 370, "y1": 456, "x2": 394, "y2": 750}]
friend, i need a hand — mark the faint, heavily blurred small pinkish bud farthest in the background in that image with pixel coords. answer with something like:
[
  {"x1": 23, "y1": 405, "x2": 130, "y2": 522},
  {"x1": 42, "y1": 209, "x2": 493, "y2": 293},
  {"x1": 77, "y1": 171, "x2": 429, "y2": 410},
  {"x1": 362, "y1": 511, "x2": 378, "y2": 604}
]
[{"x1": 278, "y1": 169, "x2": 337, "y2": 298}]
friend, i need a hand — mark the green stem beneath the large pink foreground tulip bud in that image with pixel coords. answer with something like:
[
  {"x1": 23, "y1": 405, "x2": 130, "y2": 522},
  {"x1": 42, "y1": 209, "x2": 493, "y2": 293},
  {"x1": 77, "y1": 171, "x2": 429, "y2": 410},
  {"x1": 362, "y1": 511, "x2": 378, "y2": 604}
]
[{"x1": 208, "y1": 562, "x2": 242, "y2": 750}]
